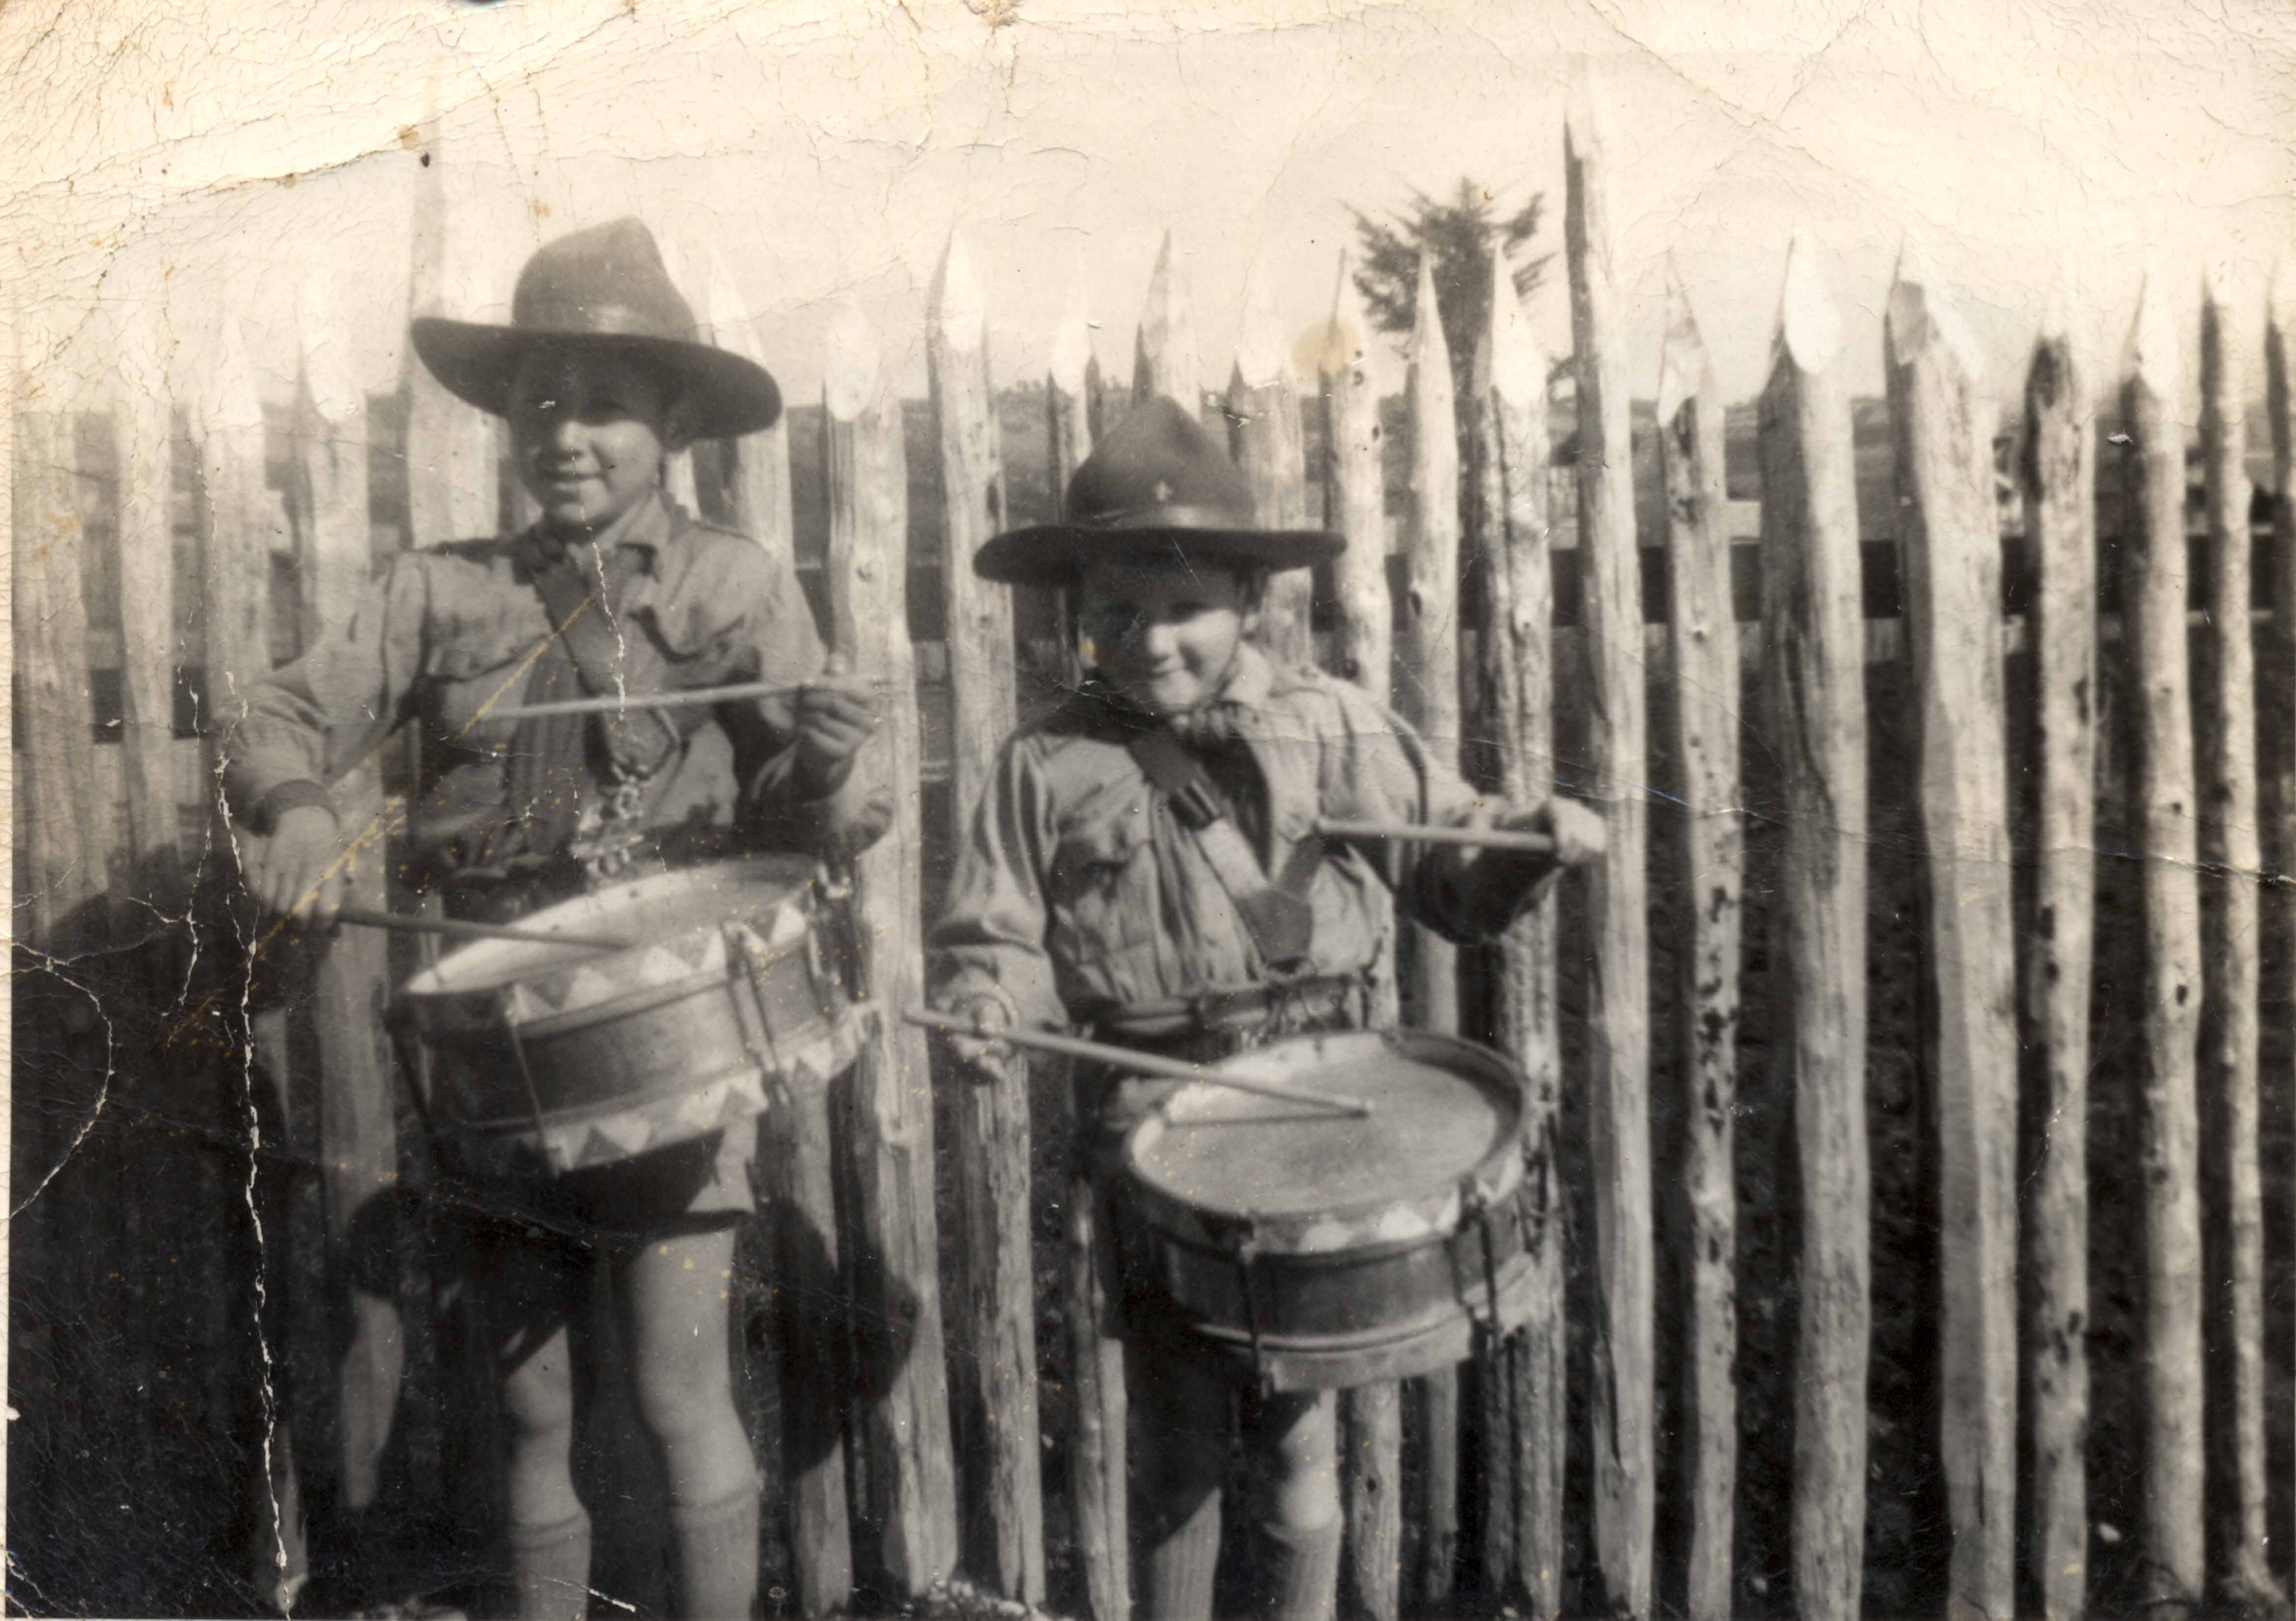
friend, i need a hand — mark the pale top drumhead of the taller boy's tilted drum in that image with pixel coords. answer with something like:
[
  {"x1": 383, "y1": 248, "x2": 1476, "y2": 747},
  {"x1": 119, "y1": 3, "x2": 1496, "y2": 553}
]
[{"x1": 402, "y1": 857, "x2": 813, "y2": 1001}]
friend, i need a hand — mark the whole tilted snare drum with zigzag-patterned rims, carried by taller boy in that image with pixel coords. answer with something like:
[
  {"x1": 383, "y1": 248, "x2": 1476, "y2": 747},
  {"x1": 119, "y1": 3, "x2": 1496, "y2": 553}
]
[{"x1": 393, "y1": 857, "x2": 866, "y2": 1171}]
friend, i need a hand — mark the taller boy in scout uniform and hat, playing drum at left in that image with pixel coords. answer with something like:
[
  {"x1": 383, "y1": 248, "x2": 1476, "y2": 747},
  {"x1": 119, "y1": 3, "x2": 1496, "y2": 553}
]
[{"x1": 225, "y1": 220, "x2": 891, "y2": 1617}]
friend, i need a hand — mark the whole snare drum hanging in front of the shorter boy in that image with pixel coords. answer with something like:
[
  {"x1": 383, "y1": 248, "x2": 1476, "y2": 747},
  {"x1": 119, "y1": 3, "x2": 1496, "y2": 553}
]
[{"x1": 1125, "y1": 1031, "x2": 1534, "y2": 1391}]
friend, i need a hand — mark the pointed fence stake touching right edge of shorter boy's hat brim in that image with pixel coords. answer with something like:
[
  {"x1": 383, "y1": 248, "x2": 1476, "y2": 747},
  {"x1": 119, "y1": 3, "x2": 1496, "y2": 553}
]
[{"x1": 1323, "y1": 255, "x2": 1403, "y2": 1621}]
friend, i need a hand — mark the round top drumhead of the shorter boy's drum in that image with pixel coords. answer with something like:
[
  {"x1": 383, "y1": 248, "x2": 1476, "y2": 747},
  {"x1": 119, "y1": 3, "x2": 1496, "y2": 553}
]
[{"x1": 1127, "y1": 1031, "x2": 1522, "y2": 1249}]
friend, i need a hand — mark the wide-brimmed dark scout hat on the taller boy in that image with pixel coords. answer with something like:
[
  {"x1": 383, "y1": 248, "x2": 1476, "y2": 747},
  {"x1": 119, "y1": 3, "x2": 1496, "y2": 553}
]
[{"x1": 413, "y1": 220, "x2": 781, "y2": 438}]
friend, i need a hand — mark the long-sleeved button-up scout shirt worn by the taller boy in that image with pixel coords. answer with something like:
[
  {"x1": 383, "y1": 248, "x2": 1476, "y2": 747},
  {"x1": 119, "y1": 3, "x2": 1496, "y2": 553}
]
[{"x1": 225, "y1": 491, "x2": 891, "y2": 882}]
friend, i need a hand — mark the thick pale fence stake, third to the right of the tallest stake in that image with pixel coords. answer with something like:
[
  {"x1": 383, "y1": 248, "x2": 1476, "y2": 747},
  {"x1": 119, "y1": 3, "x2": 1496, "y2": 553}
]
[{"x1": 1885, "y1": 248, "x2": 2016, "y2": 1621}]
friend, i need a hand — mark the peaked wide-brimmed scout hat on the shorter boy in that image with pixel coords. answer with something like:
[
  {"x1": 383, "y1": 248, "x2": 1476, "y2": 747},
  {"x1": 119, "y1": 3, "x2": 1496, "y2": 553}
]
[{"x1": 973, "y1": 395, "x2": 1348, "y2": 586}]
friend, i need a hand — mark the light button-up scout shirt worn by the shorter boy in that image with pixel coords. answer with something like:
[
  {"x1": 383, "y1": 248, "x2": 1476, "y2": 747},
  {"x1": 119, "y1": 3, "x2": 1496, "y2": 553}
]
[{"x1": 928, "y1": 643, "x2": 1522, "y2": 1027}]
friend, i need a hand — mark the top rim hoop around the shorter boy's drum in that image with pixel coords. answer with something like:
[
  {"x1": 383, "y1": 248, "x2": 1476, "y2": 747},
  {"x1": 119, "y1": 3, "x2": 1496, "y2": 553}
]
[{"x1": 1123, "y1": 1031, "x2": 1531, "y2": 1254}]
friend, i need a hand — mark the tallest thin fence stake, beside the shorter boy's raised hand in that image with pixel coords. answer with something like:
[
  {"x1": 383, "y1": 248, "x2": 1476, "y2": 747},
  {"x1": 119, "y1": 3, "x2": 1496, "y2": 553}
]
[{"x1": 1564, "y1": 74, "x2": 1658, "y2": 1621}]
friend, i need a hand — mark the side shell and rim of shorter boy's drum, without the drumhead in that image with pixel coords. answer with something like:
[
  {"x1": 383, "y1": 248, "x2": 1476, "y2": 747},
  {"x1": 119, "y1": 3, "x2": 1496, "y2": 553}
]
[{"x1": 1118, "y1": 1033, "x2": 1545, "y2": 1391}]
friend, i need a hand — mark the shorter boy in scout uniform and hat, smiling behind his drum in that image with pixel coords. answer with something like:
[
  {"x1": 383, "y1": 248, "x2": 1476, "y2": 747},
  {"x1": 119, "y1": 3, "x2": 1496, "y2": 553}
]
[{"x1": 930, "y1": 400, "x2": 1602, "y2": 1621}]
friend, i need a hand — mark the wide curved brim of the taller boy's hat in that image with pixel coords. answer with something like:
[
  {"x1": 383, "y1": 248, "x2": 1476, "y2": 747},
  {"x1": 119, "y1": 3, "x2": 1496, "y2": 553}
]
[{"x1": 411, "y1": 315, "x2": 781, "y2": 438}]
